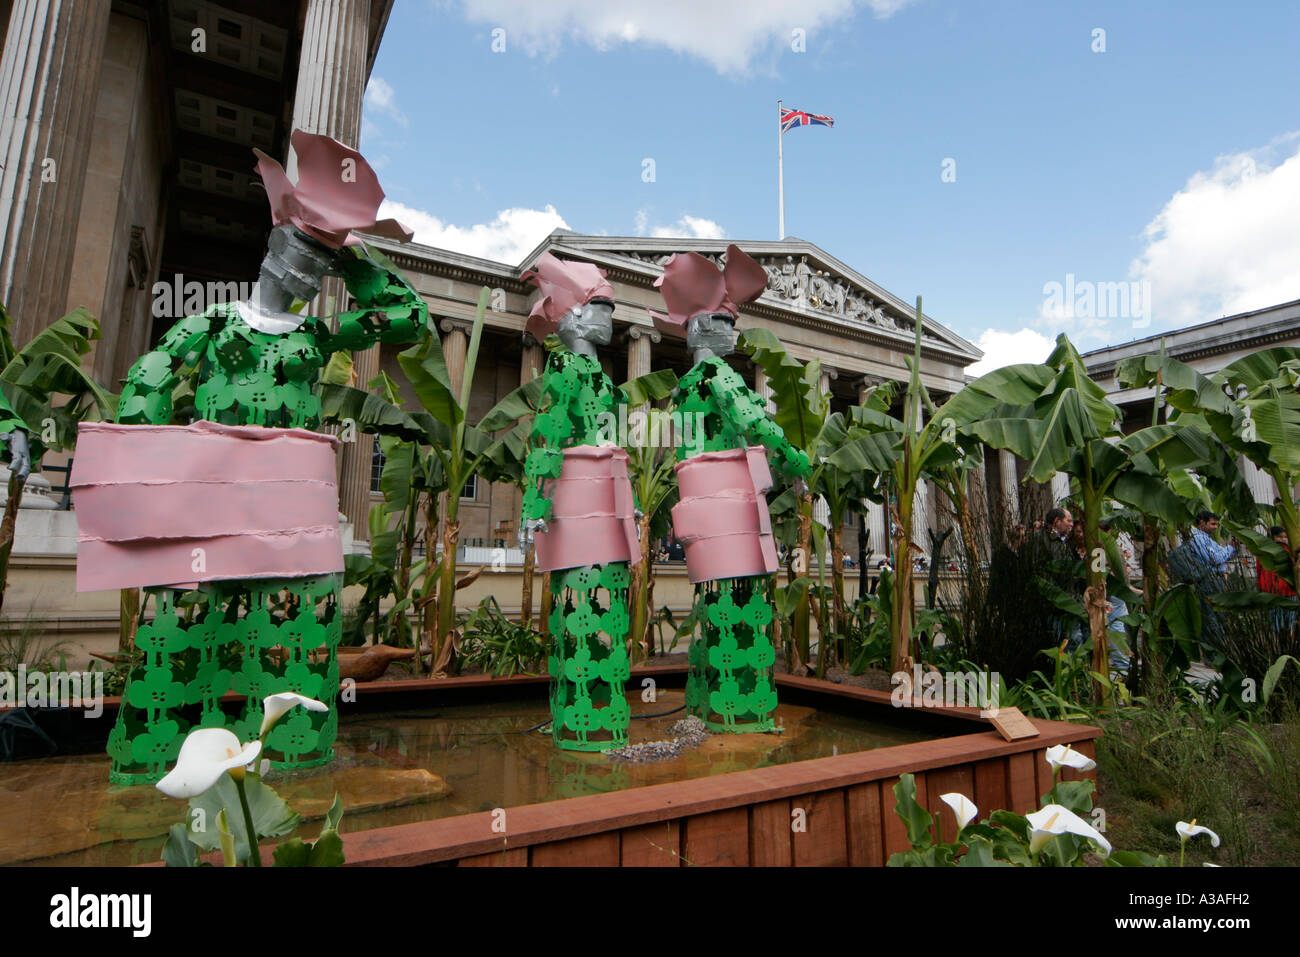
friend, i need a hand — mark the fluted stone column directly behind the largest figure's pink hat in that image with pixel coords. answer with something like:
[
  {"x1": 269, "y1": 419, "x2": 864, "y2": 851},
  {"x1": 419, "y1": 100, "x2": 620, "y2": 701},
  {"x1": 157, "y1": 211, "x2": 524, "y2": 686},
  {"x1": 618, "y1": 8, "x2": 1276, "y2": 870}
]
[{"x1": 285, "y1": 0, "x2": 380, "y2": 541}]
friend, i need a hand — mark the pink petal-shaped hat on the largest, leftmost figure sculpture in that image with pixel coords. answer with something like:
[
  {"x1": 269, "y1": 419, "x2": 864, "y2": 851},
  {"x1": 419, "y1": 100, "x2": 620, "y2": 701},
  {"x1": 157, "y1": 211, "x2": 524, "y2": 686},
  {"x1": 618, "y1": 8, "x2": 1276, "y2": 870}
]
[{"x1": 254, "y1": 130, "x2": 413, "y2": 250}]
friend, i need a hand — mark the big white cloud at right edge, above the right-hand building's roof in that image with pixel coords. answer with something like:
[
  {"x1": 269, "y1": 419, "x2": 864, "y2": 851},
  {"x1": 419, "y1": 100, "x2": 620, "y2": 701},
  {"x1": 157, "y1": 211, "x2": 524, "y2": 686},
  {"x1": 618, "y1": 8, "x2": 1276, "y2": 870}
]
[{"x1": 1130, "y1": 131, "x2": 1300, "y2": 325}]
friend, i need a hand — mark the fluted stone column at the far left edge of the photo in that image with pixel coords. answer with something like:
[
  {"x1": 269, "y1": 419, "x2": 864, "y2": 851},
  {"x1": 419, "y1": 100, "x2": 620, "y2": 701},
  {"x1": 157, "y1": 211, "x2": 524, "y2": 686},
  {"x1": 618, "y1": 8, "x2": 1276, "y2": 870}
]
[{"x1": 0, "y1": 0, "x2": 111, "y2": 347}]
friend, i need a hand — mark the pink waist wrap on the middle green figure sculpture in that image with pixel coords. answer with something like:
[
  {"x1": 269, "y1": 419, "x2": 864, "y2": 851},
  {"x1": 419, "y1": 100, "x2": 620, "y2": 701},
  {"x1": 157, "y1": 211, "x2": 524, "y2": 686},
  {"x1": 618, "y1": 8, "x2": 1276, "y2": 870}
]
[{"x1": 533, "y1": 445, "x2": 641, "y2": 572}]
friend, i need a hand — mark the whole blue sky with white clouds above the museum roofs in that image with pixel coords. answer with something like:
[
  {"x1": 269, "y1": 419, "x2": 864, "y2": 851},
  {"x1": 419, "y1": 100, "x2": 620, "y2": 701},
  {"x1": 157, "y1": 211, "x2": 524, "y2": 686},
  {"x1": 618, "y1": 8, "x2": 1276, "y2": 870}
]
[{"x1": 361, "y1": 0, "x2": 1300, "y2": 364}]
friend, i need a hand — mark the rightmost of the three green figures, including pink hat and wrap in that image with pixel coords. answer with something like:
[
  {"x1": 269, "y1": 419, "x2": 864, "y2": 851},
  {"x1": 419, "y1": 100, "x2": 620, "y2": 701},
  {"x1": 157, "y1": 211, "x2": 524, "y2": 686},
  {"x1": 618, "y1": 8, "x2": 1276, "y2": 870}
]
[{"x1": 651, "y1": 246, "x2": 809, "y2": 732}]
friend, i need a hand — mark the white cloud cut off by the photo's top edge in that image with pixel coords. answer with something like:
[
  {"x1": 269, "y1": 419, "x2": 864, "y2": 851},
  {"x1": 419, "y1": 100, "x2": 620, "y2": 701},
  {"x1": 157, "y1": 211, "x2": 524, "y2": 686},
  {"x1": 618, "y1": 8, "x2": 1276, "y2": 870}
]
[{"x1": 463, "y1": 0, "x2": 914, "y2": 74}]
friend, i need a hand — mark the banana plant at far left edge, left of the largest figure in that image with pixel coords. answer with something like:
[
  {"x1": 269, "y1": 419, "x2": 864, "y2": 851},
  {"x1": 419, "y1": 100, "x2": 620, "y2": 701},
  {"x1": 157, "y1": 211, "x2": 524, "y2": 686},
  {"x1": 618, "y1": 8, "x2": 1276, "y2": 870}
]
[{"x1": 0, "y1": 306, "x2": 117, "y2": 607}]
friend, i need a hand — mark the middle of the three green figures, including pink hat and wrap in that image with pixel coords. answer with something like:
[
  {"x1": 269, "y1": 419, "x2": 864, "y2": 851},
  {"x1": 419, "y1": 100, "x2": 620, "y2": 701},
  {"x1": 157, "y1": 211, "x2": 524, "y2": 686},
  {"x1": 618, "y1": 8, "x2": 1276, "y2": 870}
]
[{"x1": 523, "y1": 252, "x2": 641, "y2": 752}]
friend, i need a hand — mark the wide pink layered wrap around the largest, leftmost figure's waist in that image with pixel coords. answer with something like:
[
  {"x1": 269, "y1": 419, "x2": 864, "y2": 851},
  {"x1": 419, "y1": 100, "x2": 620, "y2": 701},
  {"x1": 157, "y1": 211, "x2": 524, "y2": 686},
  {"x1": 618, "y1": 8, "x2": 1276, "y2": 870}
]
[{"x1": 69, "y1": 421, "x2": 343, "y2": 592}]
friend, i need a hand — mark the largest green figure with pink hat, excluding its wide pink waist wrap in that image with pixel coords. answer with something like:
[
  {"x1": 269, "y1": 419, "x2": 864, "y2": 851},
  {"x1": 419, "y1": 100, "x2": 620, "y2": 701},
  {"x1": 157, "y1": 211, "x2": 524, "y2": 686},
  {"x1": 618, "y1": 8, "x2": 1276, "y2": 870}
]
[{"x1": 102, "y1": 131, "x2": 428, "y2": 784}]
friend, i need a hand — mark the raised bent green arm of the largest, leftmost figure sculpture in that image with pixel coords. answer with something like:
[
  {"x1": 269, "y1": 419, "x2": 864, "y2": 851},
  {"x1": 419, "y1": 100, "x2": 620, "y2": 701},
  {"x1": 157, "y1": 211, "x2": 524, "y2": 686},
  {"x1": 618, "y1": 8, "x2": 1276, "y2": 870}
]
[{"x1": 325, "y1": 246, "x2": 429, "y2": 352}]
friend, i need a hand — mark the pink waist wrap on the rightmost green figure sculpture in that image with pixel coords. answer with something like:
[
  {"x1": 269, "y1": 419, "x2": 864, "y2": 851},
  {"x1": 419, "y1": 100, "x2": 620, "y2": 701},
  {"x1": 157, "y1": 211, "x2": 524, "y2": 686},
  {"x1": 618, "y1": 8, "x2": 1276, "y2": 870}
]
[{"x1": 672, "y1": 446, "x2": 779, "y2": 583}]
